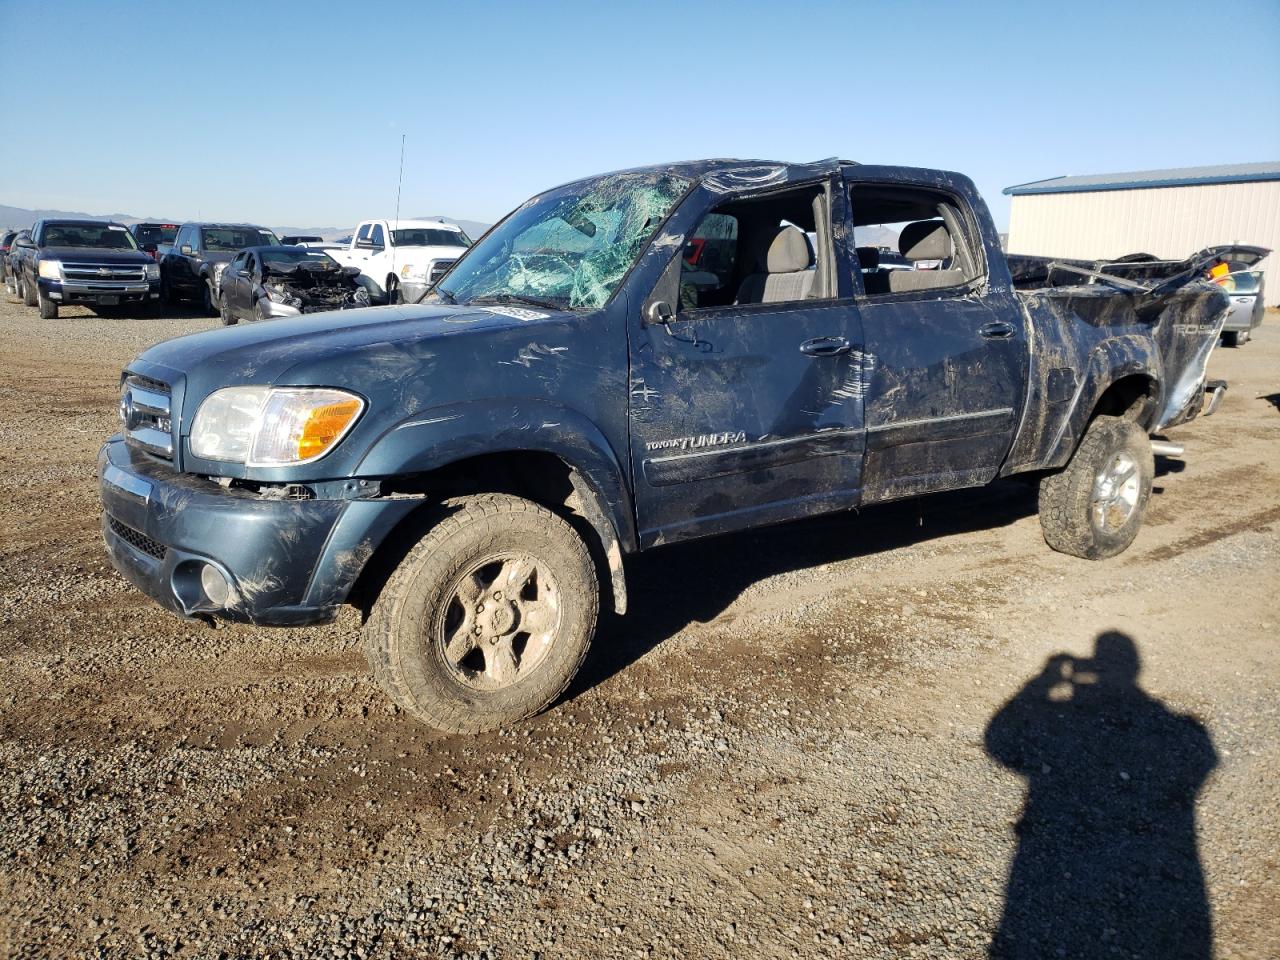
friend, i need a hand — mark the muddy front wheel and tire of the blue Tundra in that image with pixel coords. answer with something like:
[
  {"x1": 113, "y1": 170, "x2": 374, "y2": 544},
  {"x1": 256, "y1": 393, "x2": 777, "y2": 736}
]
[{"x1": 364, "y1": 494, "x2": 599, "y2": 733}]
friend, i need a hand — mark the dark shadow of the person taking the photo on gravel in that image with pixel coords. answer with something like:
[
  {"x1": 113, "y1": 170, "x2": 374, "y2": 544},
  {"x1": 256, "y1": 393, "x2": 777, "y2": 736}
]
[{"x1": 986, "y1": 631, "x2": 1217, "y2": 960}]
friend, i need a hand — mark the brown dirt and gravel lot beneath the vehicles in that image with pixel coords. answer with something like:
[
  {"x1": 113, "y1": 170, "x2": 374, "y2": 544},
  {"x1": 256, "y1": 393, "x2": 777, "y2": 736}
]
[{"x1": 0, "y1": 296, "x2": 1280, "y2": 959}]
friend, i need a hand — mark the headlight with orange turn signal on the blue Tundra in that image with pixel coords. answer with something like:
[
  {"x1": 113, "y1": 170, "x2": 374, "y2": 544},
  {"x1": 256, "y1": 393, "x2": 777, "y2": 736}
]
[{"x1": 191, "y1": 387, "x2": 365, "y2": 467}]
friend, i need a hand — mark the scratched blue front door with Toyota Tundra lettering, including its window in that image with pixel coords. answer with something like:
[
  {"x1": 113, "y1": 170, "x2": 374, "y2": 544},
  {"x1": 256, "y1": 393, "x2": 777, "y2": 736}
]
[{"x1": 630, "y1": 182, "x2": 864, "y2": 547}]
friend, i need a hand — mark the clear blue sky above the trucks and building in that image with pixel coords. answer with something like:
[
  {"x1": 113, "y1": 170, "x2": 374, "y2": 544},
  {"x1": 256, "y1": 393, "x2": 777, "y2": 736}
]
[{"x1": 0, "y1": 0, "x2": 1280, "y2": 227}]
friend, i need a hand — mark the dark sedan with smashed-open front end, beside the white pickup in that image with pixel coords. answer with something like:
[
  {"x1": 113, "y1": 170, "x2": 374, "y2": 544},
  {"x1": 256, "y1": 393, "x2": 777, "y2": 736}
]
[{"x1": 219, "y1": 246, "x2": 385, "y2": 326}]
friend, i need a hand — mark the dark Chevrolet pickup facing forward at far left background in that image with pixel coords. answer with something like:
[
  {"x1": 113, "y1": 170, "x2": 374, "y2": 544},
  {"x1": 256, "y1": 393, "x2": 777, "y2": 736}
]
[{"x1": 14, "y1": 220, "x2": 160, "y2": 320}]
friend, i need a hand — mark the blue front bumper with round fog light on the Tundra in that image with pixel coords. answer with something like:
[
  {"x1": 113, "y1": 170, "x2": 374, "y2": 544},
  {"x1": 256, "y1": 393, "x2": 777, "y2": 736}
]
[{"x1": 99, "y1": 436, "x2": 420, "y2": 626}]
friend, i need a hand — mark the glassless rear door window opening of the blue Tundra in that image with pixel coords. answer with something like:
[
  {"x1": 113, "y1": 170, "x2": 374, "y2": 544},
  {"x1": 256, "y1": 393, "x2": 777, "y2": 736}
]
[{"x1": 850, "y1": 183, "x2": 986, "y2": 298}]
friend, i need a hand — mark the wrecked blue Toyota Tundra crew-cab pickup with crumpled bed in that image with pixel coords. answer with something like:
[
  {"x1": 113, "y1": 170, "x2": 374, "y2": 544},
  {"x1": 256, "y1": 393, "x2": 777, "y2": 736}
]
[{"x1": 99, "y1": 160, "x2": 1259, "y2": 731}]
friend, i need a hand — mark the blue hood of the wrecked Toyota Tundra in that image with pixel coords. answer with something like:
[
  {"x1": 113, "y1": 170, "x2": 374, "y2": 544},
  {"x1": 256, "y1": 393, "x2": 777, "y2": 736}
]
[{"x1": 129, "y1": 305, "x2": 573, "y2": 401}]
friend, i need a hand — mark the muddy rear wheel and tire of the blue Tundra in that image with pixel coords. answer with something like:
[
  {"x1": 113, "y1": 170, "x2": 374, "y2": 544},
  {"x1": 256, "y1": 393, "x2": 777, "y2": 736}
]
[{"x1": 1039, "y1": 416, "x2": 1156, "y2": 559}]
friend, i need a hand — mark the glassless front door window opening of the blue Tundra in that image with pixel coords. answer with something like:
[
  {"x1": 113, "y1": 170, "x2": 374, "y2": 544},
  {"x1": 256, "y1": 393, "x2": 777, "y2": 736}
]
[{"x1": 680, "y1": 184, "x2": 835, "y2": 310}]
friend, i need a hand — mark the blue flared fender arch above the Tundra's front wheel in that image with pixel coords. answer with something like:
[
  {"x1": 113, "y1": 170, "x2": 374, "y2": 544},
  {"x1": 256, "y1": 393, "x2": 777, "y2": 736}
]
[{"x1": 355, "y1": 398, "x2": 636, "y2": 552}]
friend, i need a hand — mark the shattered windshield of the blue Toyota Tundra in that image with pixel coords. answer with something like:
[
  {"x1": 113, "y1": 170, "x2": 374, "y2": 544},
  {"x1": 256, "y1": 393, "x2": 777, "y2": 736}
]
[{"x1": 439, "y1": 173, "x2": 690, "y2": 310}]
